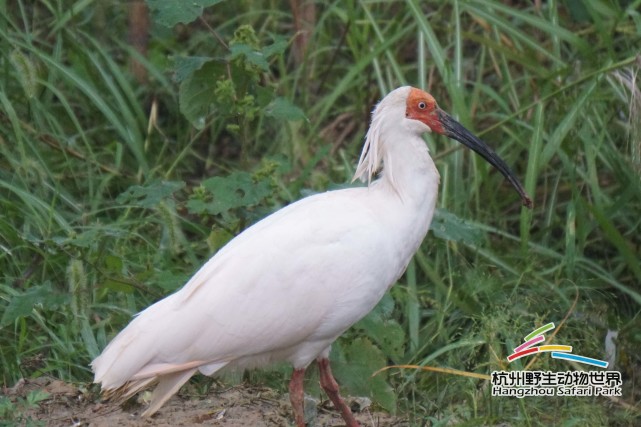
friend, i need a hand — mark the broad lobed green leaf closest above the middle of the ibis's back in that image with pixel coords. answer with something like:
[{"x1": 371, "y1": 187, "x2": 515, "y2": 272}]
[{"x1": 187, "y1": 172, "x2": 271, "y2": 215}]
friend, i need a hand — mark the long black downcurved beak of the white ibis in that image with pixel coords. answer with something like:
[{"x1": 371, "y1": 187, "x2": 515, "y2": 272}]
[{"x1": 436, "y1": 109, "x2": 532, "y2": 209}]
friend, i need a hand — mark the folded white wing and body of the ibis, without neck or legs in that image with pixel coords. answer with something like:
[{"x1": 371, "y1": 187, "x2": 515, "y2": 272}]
[{"x1": 92, "y1": 188, "x2": 402, "y2": 389}]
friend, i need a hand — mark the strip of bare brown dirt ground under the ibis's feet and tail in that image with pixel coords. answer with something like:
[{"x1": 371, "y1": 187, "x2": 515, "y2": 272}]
[{"x1": 5, "y1": 378, "x2": 408, "y2": 427}]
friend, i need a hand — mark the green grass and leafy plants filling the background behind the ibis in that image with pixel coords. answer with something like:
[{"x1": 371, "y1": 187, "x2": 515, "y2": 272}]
[{"x1": 0, "y1": 0, "x2": 641, "y2": 425}]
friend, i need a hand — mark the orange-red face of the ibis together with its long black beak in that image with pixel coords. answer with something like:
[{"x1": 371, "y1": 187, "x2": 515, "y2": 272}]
[{"x1": 405, "y1": 88, "x2": 532, "y2": 208}]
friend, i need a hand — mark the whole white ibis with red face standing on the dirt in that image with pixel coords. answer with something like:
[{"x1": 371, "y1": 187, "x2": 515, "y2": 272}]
[{"x1": 91, "y1": 86, "x2": 532, "y2": 427}]
